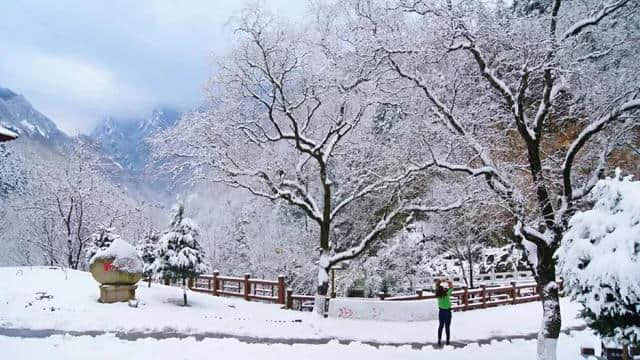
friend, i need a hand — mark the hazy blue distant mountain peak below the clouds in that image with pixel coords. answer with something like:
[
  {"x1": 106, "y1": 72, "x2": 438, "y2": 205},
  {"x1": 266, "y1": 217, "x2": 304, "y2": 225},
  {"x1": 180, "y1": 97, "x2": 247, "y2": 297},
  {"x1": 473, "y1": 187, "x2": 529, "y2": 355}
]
[{"x1": 90, "y1": 108, "x2": 180, "y2": 175}]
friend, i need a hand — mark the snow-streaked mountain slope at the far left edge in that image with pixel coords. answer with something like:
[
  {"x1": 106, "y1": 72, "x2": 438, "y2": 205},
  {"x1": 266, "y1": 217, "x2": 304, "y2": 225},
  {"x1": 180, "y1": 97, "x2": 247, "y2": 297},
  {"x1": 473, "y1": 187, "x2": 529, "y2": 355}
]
[{"x1": 0, "y1": 87, "x2": 71, "y2": 148}]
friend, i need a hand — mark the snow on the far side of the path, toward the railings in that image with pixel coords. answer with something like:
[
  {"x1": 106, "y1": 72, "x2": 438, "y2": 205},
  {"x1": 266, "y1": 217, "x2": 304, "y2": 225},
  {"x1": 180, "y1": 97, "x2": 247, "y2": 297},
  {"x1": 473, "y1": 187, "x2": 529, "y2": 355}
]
[{"x1": 0, "y1": 267, "x2": 585, "y2": 344}]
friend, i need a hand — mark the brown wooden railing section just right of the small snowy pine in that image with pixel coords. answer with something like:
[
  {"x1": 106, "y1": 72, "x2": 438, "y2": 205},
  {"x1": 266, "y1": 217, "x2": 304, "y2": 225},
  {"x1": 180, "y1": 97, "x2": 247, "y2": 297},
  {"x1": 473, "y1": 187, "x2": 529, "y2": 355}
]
[{"x1": 189, "y1": 271, "x2": 287, "y2": 305}]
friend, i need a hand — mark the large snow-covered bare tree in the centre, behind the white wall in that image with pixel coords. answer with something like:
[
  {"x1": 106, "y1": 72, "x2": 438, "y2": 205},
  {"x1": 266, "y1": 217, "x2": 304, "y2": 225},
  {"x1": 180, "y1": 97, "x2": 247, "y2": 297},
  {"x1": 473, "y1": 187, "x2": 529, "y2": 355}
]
[{"x1": 153, "y1": 10, "x2": 461, "y2": 312}]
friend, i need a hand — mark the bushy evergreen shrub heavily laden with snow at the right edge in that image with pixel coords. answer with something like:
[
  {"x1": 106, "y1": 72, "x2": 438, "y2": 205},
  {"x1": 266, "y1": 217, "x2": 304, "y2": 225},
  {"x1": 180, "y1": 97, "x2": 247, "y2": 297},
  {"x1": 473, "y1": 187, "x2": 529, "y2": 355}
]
[{"x1": 556, "y1": 169, "x2": 640, "y2": 344}]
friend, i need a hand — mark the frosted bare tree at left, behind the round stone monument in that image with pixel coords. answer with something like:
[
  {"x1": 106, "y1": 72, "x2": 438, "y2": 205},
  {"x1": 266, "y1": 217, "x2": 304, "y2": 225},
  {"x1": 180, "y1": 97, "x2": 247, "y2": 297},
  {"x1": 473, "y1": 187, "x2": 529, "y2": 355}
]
[{"x1": 8, "y1": 141, "x2": 137, "y2": 269}]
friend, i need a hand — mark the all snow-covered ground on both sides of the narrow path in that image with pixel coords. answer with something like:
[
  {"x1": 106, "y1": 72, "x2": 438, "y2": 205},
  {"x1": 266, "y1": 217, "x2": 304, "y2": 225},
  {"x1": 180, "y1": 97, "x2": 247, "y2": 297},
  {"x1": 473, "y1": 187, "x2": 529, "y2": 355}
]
[{"x1": 0, "y1": 267, "x2": 597, "y2": 359}]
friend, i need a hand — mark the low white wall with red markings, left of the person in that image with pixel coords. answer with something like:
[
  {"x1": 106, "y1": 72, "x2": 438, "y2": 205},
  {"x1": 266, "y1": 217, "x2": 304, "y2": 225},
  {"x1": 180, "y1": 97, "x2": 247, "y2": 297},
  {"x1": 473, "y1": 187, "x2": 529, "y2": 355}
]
[{"x1": 329, "y1": 298, "x2": 438, "y2": 321}]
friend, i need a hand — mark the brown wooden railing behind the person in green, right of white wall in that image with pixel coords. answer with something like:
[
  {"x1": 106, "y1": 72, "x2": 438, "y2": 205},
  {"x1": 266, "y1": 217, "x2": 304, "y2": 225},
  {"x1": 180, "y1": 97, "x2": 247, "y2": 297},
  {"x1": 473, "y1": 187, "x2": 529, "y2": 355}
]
[{"x1": 379, "y1": 282, "x2": 540, "y2": 311}]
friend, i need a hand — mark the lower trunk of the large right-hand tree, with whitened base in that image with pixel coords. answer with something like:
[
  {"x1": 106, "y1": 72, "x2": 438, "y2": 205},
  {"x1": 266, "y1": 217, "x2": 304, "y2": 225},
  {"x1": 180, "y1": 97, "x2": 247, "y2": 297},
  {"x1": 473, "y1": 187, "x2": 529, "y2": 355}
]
[{"x1": 537, "y1": 248, "x2": 562, "y2": 360}]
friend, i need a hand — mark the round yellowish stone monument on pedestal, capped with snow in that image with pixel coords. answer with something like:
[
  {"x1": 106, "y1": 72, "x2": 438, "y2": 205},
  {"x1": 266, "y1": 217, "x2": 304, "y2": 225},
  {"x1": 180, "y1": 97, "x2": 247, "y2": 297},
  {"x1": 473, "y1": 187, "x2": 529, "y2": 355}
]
[{"x1": 89, "y1": 239, "x2": 143, "y2": 303}]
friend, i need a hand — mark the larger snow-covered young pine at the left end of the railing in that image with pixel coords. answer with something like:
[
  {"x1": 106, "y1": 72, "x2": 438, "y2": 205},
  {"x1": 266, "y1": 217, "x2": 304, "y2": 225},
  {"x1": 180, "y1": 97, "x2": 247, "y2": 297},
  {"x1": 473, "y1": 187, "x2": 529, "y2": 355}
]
[{"x1": 153, "y1": 203, "x2": 207, "y2": 305}]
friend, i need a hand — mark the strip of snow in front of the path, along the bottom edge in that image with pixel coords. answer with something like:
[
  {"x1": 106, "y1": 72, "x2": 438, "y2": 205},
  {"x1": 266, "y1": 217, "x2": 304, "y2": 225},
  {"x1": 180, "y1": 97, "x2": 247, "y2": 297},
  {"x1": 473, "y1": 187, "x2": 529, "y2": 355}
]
[{"x1": 0, "y1": 331, "x2": 599, "y2": 360}]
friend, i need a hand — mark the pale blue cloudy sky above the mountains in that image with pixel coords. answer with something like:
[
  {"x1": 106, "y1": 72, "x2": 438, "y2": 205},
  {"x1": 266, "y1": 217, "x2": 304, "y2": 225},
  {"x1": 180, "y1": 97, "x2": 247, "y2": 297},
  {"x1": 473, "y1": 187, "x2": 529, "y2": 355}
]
[{"x1": 0, "y1": 0, "x2": 306, "y2": 134}]
